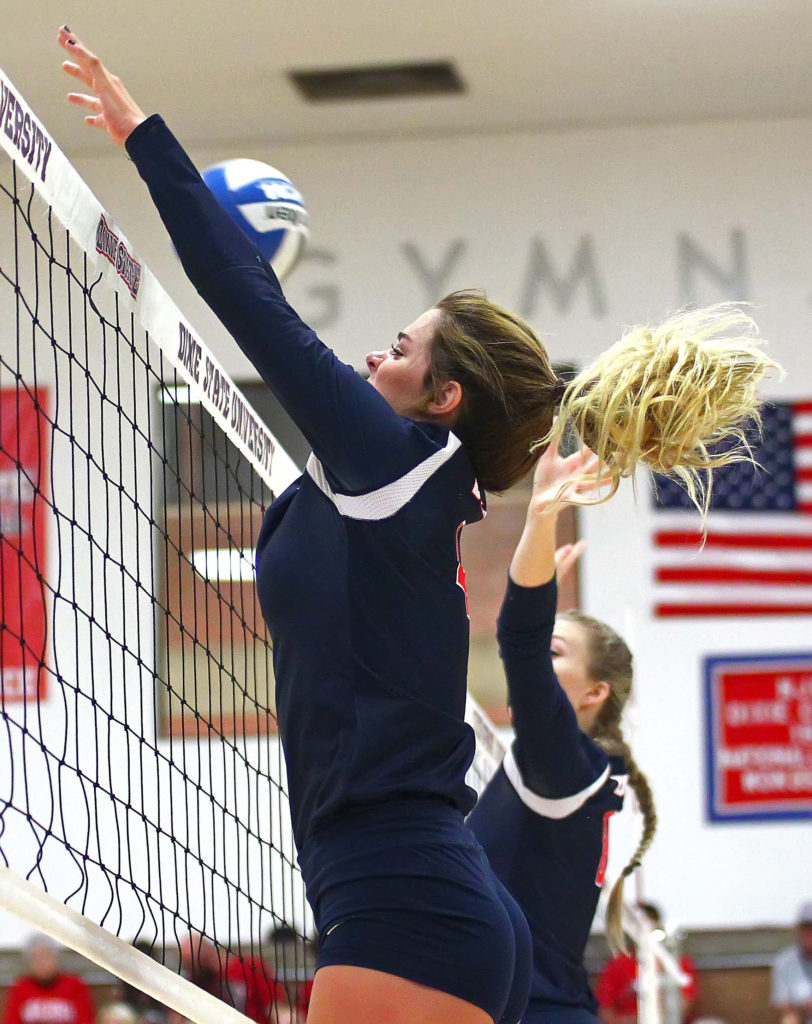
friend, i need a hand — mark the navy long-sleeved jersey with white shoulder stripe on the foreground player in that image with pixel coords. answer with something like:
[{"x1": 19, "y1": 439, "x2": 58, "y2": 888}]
[{"x1": 127, "y1": 116, "x2": 484, "y2": 848}]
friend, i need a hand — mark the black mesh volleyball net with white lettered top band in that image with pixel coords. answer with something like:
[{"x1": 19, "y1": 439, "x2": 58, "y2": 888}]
[{"x1": 0, "y1": 70, "x2": 305, "y2": 1022}]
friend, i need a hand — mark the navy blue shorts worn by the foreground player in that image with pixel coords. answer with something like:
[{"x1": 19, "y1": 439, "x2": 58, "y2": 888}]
[{"x1": 299, "y1": 800, "x2": 532, "y2": 1024}]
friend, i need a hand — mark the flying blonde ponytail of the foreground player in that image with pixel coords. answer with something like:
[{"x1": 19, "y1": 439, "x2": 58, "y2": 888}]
[{"x1": 542, "y1": 304, "x2": 779, "y2": 515}]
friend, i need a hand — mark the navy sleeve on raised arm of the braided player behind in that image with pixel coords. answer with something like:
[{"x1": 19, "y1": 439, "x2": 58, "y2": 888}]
[{"x1": 498, "y1": 578, "x2": 607, "y2": 798}]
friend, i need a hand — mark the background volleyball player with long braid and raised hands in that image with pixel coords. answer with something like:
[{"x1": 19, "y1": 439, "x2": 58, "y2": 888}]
[{"x1": 468, "y1": 436, "x2": 656, "y2": 1024}]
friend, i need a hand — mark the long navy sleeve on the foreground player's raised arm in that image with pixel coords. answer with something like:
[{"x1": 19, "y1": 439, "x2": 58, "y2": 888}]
[{"x1": 126, "y1": 115, "x2": 436, "y2": 490}]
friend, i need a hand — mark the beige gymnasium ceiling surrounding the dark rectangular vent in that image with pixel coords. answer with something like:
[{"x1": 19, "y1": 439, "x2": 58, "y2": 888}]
[{"x1": 0, "y1": 0, "x2": 812, "y2": 154}]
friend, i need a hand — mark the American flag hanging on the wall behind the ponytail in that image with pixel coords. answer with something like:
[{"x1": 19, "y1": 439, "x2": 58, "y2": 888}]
[{"x1": 651, "y1": 401, "x2": 812, "y2": 617}]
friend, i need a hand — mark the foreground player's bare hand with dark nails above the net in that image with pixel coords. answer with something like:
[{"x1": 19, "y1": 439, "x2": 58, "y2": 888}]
[{"x1": 57, "y1": 26, "x2": 146, "y2": 145}]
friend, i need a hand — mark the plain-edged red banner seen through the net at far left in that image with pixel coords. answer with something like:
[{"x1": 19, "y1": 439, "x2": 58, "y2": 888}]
[{"x1": 0, "y1": 384, "x2": 49, "y2": 700}]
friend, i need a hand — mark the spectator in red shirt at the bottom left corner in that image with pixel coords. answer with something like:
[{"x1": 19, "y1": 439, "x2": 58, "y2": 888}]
[{"x1": 2, "y1": 935, "x2": 95, "y2": 1024}]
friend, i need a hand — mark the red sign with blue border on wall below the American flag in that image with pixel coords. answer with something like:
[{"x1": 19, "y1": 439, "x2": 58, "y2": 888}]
[{"x1": 706, "y1": 654, "x2": 812, "y2": 821}]
